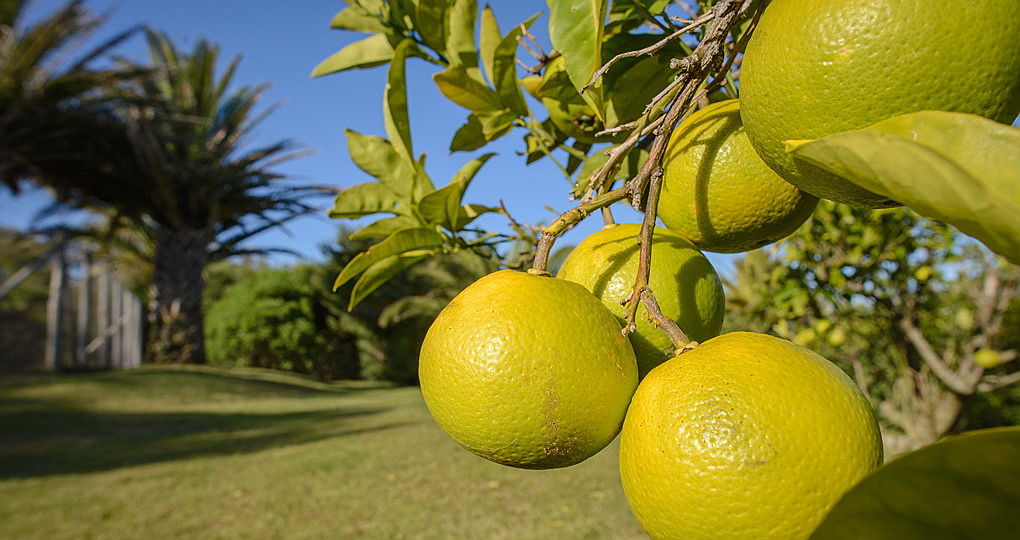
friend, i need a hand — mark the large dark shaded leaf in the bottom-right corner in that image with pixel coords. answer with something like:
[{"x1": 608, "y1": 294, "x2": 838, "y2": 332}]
[{"x1": 811, "y1": 427, "x2": 1020, "y2": 540}]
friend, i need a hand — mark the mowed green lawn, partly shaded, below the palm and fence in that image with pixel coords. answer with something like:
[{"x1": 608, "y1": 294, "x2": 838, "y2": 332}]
[{"x1": 0, "y1": 366, "x2": 643, "y2": 539}]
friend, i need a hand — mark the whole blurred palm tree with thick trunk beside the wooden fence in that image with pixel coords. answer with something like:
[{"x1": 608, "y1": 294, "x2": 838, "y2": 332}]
[{"x1": 32, "y1": 31, "x2": 319, "y2": 363}]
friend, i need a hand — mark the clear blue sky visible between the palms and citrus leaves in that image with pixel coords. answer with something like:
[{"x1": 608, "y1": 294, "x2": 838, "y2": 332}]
[{"x1": 0, "y1": 0, "x2": 732, "y2": 274}]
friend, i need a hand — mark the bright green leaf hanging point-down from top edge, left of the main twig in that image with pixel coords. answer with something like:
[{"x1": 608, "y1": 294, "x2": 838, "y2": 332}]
[{"x1": 547, "y1": 0, "x2": 606, "y2": 118}]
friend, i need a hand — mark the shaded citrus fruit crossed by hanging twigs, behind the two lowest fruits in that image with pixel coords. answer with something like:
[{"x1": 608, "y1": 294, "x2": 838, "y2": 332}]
[{"x1": 557, "y1": 224, "x2": 725, "y2": 376}]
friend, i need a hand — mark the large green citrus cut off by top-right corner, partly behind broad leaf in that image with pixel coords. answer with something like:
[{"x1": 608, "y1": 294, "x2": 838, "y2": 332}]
[{"x1": 741, "y1": 0, "x2": 1020, "y2": 207}]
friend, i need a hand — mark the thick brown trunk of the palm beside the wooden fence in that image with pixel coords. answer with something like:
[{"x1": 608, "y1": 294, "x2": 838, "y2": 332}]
[{"x1": 149, "y1": 228, "x2": 212, "y2": 363}]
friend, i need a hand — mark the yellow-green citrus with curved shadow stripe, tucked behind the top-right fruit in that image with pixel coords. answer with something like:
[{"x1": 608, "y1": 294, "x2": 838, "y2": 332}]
[{"x1": 659, "y1": 99, "x2": 818, "y2": 253}]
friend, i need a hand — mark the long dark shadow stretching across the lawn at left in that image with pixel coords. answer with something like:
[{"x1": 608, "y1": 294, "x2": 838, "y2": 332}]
[{"x1": 0, "y1": 371, "x2": 411, "y2": 479}]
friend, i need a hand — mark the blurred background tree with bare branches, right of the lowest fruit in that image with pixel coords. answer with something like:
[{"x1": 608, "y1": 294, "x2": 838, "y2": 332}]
[{"x1": 727, "y1": 203, "x2": 1020, "y2": 454}]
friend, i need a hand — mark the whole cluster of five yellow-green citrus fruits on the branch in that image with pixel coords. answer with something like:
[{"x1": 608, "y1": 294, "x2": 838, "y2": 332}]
[{"x1": 419, "y1": 0, "x2": 1020, "y2": 538}]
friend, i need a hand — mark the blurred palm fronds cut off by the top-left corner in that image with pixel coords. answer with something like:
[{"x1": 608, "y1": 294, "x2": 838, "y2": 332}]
[{"x1": 0, "y1": 0, "x2": 137, "y2": 191}]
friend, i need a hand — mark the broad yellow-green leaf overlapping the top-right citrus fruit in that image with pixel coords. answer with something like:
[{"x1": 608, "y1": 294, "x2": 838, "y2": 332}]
[{"x1": 787, "y1": 111, "x2": 1020, "y2": 263}]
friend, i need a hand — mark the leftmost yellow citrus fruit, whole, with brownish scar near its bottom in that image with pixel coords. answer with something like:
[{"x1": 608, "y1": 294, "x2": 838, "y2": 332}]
[{"x1": 418, "y1": 271, "x2": 638, "y2": 469}]
